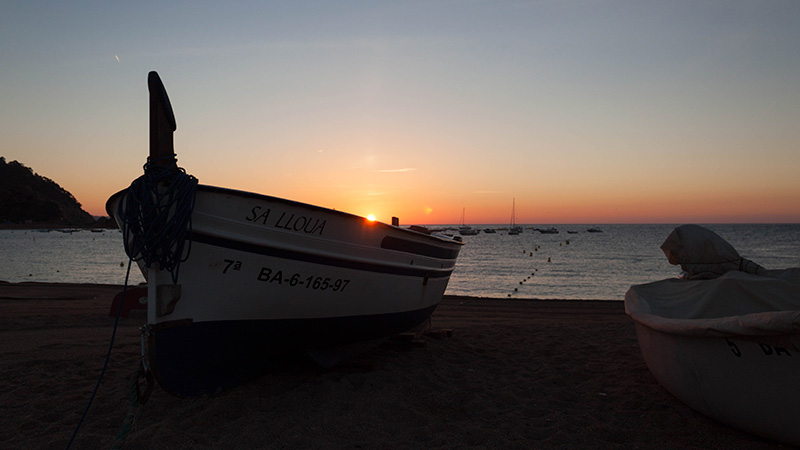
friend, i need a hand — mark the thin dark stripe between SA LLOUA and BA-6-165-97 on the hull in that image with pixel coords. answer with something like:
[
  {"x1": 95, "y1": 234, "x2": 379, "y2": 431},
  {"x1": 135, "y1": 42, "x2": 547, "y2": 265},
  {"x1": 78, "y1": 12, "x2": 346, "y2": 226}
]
[{"x1": 192, "y1": 231, "x2": 453, "y2": 278}]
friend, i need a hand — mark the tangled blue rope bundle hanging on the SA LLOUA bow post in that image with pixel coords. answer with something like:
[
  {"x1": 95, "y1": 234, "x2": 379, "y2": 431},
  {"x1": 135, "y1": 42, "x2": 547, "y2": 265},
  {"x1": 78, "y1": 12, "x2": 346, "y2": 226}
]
[{"x1": 118, "y1": 156, "x2": 197, "y2": 283}]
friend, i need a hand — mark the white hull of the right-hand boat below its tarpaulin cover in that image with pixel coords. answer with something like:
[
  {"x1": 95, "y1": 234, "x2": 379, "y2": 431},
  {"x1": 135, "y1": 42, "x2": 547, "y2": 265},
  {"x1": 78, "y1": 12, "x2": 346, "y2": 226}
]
[{"x1": 636, "y1": 323, "x2": 800, "y2": 446}]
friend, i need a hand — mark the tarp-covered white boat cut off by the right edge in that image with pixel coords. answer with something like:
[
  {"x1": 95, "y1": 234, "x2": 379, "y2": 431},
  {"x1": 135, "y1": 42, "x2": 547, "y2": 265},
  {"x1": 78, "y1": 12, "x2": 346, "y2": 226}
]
[{"x1": 625, "y1": 225, "x2": 800, "y2": 446}]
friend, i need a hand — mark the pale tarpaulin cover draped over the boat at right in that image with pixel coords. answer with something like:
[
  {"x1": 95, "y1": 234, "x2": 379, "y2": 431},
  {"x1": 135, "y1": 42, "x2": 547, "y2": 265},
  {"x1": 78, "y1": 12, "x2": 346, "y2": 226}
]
[{"x1": 625, "y1": 225, "x2": 800, "y2": 336}]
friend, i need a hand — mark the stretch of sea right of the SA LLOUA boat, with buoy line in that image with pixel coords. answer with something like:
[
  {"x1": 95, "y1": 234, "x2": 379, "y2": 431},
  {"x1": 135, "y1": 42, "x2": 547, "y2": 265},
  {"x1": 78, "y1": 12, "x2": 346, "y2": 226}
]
[{"x1": 447, "y1": 224, "x2": 800, "y2": 300}]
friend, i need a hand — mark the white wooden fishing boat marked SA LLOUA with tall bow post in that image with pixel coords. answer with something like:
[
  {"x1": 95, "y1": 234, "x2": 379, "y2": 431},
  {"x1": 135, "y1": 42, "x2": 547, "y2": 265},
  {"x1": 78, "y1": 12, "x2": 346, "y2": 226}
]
[{"x1": 106, "y1": 72, "x2": 462, "y2": 397}]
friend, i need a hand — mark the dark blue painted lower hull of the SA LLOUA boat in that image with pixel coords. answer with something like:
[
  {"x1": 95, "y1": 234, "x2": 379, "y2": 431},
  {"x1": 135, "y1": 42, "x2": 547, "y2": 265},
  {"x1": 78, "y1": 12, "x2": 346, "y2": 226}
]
[{"x1": 148, "y1": 305, "x2": 437, "y2": 397}]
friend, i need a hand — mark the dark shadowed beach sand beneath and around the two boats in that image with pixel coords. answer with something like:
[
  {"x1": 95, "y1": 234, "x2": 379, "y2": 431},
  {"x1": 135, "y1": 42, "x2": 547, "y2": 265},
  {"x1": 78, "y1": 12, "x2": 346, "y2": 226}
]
[{"x1": 0, "y1": 283, "x2": 780, "y2": 450}]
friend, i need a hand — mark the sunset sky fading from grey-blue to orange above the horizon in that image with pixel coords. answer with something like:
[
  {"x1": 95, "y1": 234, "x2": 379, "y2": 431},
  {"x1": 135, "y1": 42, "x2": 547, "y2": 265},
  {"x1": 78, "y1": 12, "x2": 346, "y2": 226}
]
[{"x1": 0, "y1": 0, "x2": 800, "y2": 224}]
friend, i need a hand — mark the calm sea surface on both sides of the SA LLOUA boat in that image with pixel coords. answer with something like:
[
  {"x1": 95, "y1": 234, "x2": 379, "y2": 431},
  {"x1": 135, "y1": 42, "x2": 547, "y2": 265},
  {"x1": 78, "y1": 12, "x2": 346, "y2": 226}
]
[{"x1": 0, "y1": 224, "x2": 800, "y2": 300}]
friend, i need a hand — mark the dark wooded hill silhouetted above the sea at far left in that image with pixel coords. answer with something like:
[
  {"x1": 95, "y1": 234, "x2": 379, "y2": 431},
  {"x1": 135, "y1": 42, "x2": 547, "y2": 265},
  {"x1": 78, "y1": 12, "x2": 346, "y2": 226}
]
[{"x1": 0, "y1": 156, "x2": 105, "y2": 227}]
